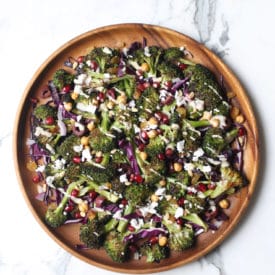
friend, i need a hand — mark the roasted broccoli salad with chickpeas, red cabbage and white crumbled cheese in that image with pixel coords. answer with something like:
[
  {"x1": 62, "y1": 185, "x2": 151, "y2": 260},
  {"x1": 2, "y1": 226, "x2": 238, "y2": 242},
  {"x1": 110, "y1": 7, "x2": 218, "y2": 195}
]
[{"x1": 27, "y1": 41, "x2": 247, "y2": 262}]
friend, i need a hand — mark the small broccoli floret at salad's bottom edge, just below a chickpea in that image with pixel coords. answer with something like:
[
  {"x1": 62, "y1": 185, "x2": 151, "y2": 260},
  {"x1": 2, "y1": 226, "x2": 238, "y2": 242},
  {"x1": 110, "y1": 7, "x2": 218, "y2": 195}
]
[{"x1": 140, "y1": 242, "x2": 169, "y2": 263}]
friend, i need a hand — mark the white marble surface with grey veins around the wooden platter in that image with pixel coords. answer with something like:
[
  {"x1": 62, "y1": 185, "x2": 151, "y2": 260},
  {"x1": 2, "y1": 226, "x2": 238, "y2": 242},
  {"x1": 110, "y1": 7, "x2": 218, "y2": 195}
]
[{"x1": 0, "y1": 0, "x2": 275, "y2": 275}]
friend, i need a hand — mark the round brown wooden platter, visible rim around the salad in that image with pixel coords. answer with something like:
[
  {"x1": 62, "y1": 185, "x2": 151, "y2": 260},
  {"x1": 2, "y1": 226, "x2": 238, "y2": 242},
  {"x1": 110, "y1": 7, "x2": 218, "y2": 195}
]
[{"x1": 14, "y1": 24, "x2": 259, "y2": 273}]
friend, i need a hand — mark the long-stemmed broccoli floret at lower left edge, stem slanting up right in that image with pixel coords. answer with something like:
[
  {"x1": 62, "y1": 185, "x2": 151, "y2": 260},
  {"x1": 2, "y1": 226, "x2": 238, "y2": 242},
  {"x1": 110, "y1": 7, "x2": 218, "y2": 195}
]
[{"x1": 45, "y1": 180, "x2": 83, "y2": 228}]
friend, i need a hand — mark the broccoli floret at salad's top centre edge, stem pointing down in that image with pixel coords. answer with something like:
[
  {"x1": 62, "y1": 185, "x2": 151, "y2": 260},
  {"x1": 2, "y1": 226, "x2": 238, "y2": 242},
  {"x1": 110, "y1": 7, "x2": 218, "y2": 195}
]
[{"x1": 132, "y1": 46, "x2": 163, "y2": 76}]
